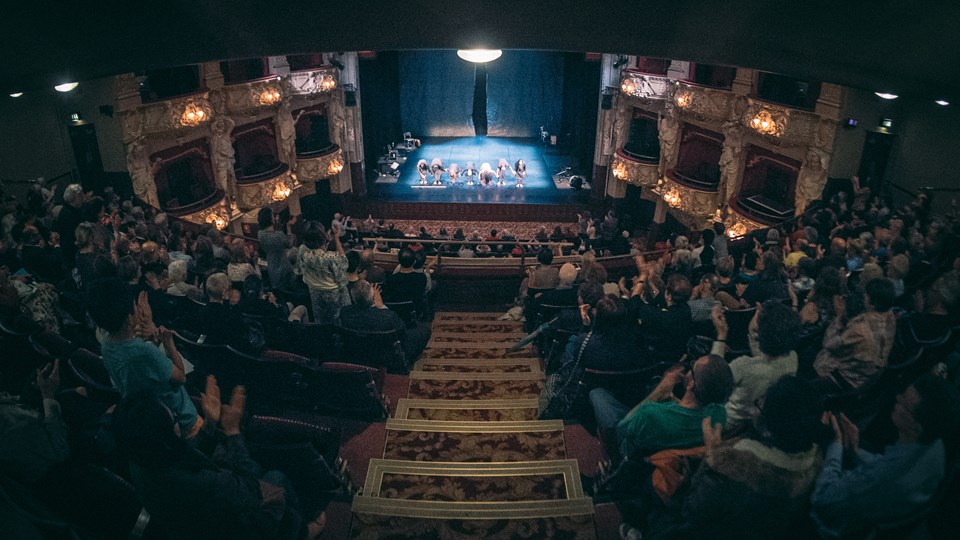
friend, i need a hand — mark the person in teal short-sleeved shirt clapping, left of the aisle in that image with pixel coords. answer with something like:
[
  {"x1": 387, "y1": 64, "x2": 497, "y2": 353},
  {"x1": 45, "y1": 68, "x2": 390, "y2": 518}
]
[{"x1": 87, "y1": 278, "x2": 203, "y2": 438}]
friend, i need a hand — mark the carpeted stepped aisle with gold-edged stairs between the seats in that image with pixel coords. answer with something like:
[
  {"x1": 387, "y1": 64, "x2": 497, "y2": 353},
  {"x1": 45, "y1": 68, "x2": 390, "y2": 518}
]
[{"x1": 350, "y1": 313, "x2": 596, "y2": 539}]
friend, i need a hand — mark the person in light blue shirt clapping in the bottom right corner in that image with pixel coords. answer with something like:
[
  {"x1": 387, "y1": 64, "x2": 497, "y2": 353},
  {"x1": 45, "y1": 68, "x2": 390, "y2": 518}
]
[{"x1": 810, "y1": 375, "x2": 960, "y2": 538}]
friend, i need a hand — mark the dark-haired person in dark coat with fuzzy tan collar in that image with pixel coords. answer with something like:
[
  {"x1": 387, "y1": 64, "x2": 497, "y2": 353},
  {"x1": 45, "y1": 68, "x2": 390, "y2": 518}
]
[{"x1": 636, "y1": 377, "x2": 822, "y2": 540}]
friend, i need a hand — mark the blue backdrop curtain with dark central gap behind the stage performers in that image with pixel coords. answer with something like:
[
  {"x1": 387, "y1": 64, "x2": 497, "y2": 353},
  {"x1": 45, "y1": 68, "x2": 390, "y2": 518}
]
[{"x1": 399, "y1": 50, "x2": 564, "y2": 137}]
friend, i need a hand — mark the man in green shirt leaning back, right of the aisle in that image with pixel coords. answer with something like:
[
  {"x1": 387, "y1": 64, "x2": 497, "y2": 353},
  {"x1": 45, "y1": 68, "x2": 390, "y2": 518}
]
[{"x1": 590, "y1": 354, "x2": 733, "y2": 456}]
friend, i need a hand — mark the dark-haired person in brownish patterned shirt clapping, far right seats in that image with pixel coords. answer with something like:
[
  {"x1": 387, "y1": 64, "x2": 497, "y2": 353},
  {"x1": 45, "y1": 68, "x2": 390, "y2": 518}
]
[{"x1": 813, "y1": 279, "x2": 896, "y2": 388}]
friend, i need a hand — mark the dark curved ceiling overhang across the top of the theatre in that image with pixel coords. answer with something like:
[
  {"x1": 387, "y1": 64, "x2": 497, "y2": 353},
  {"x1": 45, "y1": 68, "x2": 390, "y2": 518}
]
[{"x1": 0, "y1": 0, "x2": 960, "y2": 99}]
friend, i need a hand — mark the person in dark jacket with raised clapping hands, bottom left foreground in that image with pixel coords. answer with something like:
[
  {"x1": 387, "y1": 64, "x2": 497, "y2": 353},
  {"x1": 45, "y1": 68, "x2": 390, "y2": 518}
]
[{"x1": 113, "y1": 376, "x2": 325, "y2": 539}]
